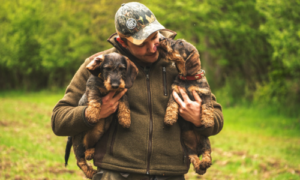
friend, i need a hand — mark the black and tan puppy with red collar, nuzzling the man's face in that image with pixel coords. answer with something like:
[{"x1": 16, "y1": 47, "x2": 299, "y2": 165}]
[{"x1": 158, "y1": 39, "x2": 214, "y2": 174}]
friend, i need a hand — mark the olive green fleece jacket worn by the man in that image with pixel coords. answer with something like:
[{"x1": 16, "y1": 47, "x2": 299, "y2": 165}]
[{"x1": 52, "y1": 30, "x2": 223, "y2": 176}]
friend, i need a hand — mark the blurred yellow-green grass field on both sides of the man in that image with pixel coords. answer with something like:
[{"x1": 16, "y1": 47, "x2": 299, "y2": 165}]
[{"x1": 0, "y1": 91, "x2": 300, "y2": 180}]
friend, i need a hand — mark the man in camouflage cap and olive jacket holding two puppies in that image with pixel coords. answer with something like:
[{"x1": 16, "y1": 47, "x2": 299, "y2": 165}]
[{"x1": 52, "y1": 2, "x2": 223, "y2": 180}]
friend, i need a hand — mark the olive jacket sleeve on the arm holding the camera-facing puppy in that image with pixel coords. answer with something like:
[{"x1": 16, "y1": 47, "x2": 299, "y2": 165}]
[{"x1": 51, "y1": 59, "x2": 93, "y2": 136}]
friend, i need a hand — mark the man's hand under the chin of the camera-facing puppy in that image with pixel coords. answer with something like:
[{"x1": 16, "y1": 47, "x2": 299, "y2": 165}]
[{"x1": 85, "y1": 89, "x2": 127, "y2": 119}]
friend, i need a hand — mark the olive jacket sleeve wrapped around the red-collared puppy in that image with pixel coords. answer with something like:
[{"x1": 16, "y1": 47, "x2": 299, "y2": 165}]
[{"x1": 194, "y1": 94, "x2": 224, "y2": 137}]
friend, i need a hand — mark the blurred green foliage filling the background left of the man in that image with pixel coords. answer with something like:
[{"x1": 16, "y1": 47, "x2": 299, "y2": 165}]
[{"x1": 0, "y1": 0, "x2": 129, "y2": 89}]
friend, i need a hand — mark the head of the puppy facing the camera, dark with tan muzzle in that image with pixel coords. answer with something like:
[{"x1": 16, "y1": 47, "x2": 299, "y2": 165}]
[{"x1": 87, "y1": 53, "x2": 138, "y2": 91}]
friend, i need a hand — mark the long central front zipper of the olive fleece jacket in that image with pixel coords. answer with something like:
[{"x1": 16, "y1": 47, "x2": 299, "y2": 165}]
[{"x1": 145, "y1": 69, "x2": 153, "y2": 174}]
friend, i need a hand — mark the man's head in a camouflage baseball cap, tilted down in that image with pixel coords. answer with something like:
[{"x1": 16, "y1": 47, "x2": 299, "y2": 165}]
[{"x1": 115, "y1": 2, "x2": 165, "y2": 64}]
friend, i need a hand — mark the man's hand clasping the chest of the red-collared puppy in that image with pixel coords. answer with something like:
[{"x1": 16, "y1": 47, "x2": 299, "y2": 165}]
[{"x1": 173, "y1": 87, "x2": 202, "y2": 127}]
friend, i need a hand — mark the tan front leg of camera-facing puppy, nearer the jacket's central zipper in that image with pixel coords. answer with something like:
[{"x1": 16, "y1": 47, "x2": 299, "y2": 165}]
[{"x1": 118, "y1": 94, "x2": 131, "y2": 128}]
